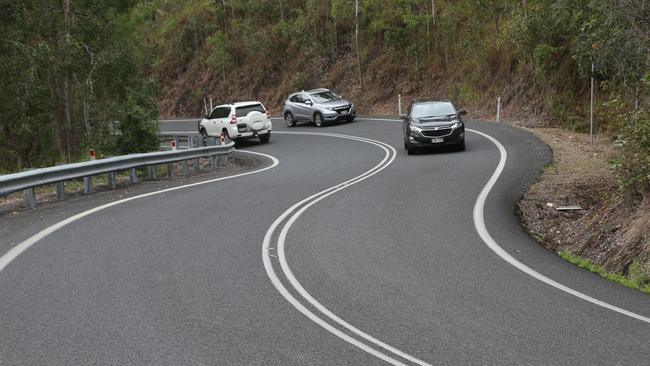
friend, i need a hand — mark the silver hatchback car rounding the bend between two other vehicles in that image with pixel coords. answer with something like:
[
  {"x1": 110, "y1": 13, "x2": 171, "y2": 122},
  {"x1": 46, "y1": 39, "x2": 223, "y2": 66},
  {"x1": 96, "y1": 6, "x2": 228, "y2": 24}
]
[{"x1": 284, "y1": 89, "x2": 357, "y2": 127}]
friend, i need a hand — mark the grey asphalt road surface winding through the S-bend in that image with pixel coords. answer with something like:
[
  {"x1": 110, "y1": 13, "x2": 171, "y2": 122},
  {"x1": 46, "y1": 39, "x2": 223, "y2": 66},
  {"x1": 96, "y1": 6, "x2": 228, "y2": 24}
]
[{"x1": 0, "y1": 119, "x2": 650, "y2": 365}]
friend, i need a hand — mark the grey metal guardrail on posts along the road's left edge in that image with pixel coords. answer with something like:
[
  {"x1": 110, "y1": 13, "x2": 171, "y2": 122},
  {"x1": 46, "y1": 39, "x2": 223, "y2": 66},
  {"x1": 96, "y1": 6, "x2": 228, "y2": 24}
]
[{"x1": 0, "y1": 137, "x2": 235, "y2": 208}]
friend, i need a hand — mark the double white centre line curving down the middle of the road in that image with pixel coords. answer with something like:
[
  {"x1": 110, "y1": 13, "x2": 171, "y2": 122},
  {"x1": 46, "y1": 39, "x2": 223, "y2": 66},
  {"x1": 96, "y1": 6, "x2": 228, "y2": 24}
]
[{"x1": 262, "y1": 132, "x2": 429, "y2": 366}]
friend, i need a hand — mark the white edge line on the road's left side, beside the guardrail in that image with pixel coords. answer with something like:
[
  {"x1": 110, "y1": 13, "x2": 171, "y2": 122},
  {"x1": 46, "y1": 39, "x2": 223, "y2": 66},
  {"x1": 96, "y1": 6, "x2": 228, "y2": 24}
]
[{"x1": 0, "y1": 150, "x2": 280, "y2": 272}]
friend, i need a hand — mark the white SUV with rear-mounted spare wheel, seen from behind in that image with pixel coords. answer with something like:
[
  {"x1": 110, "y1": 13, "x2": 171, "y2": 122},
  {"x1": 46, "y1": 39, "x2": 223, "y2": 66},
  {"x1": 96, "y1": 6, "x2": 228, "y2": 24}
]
[{"x1": 198, "y1": 102, "x2": 271, "y2": 142}]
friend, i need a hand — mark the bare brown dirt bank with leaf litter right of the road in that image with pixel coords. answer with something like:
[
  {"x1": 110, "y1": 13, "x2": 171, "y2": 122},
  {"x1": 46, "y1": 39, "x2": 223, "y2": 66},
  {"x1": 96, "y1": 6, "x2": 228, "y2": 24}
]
[{"x1": 519, "y1": 129, "x2": 650, "y2": 275}]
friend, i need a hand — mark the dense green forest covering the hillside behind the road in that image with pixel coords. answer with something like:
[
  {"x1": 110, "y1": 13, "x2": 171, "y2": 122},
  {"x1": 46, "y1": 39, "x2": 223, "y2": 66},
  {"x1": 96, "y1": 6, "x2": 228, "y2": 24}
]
[{"x1": 0, "y1": 0, "x2": 650, "y2": 197}]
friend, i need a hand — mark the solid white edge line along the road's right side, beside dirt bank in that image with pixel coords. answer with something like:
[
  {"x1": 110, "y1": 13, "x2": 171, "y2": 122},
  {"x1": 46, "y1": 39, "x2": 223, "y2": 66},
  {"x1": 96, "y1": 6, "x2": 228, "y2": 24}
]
[{"x1": 467, "y1": 129, "x2": 650, "y2": 324}]
